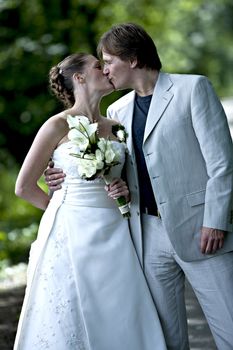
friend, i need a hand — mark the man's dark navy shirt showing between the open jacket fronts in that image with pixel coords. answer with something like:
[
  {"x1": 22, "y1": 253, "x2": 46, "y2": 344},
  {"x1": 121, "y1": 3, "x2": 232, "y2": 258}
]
[{"x1": 132, "y1": 94, "x2": 157, "y2": 216}]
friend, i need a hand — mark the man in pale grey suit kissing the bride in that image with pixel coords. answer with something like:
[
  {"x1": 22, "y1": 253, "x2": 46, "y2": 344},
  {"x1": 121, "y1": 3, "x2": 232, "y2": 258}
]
[{"x1": 46, "y1": 23, "x2": 233, "y2": 350}]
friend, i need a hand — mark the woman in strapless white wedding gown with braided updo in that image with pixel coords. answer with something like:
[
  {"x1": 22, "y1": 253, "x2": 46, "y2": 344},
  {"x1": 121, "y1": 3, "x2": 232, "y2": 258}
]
[{"x1": 14, "y1": 54, "x2": 166, "y2": 350}]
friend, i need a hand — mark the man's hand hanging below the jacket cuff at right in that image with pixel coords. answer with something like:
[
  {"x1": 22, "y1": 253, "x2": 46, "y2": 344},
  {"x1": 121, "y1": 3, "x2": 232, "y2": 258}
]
[{"x1": 201, "y1": 227, "x2": 225, "y2": 254}]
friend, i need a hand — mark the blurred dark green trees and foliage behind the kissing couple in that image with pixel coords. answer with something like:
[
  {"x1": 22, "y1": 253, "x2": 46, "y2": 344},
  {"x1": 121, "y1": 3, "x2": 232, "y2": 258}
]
[{"x1": 0, "y1": 0, "x2": 233, "y2": 270}]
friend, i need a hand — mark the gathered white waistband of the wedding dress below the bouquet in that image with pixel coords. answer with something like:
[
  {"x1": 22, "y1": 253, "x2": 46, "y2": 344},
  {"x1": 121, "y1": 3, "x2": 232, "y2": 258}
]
[{"x1": 51, "y1": 181, "x2": 115, "y2": 208}]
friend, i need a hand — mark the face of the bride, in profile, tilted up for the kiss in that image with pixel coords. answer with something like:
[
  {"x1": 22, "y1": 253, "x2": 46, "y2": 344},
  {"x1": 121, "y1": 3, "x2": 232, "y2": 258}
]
[{"x1": 84, "y1": 56, "x2": 114, "y2": 96}]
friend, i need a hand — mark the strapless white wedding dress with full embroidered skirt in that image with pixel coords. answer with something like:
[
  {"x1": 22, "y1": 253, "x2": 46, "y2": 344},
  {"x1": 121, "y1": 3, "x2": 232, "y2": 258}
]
[{"x1": 14, "y1": 142, "x2": 166, "y2": 350}]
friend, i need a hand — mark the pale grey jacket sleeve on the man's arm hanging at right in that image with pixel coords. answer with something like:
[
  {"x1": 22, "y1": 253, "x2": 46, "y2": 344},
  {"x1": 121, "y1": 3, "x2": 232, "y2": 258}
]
[{"x1": 191, "y1": 77, "x2": 233, "y2": 231}]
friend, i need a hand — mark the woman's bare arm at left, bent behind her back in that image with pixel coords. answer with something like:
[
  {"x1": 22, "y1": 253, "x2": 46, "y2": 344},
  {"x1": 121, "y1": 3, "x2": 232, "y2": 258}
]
[{"x1": 15, "y1": 117, "x2": 67, "y2": 210}]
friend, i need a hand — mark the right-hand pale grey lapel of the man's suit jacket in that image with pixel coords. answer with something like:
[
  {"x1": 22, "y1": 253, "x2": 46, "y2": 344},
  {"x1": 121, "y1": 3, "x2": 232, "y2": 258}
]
[{"x1": 143, "y1": 73, "x2": 173, "y2": 143}]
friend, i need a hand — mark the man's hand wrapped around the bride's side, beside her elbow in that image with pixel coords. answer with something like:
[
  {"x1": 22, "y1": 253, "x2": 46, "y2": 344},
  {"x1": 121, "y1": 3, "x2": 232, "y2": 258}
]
[{"x1": 44, "y1": 161, "x2": 66, "y2": 192}]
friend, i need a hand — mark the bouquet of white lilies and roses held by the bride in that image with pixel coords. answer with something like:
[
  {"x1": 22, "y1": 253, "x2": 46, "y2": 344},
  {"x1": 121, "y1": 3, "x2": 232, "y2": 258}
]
[{"x1": 67, "y1": 115, "x2": 130, "y2": 218}]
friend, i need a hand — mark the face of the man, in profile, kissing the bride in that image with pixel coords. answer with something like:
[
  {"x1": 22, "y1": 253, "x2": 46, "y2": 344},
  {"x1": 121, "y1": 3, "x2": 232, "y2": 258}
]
[{"x1": 102, "y1": 51, "x2": 132, "y2": 90}]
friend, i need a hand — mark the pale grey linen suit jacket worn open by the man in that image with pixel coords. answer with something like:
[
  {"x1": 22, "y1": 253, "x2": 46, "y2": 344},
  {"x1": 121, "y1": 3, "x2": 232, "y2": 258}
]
[{"x1": 107, "y1": 72, "x2": 233, "y2": 262}]
